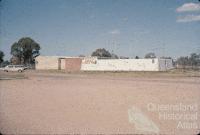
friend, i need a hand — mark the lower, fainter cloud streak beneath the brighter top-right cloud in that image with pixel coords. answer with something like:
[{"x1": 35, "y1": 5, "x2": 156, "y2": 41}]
[{"x1": 176, "y1": 15, "x2": 200, "y2": 22}]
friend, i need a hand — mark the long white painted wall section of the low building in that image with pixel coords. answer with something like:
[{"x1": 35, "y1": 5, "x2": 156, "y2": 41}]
[{"x1": 81, "y1": 59, "x2": 159, "y2": 71}]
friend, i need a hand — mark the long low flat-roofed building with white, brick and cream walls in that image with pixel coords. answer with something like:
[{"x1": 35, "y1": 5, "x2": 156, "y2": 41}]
[{"x1": 36, "y1": 56, "x2": 173, "y2": 71}]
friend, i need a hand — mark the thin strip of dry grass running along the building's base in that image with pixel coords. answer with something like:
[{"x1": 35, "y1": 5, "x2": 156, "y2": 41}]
[{"x1": 16, "y1": 69, "x2": 200, "y2": 77}]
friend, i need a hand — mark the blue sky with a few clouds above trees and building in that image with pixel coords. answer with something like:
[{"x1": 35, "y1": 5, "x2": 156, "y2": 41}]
[{"x1": 0, "y1": 0, "x2": 200, "y2": 59}]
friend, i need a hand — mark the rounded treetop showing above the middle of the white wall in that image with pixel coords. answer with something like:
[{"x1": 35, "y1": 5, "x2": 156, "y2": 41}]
[{"x1": 92, "y1": 48, "x2": 112, "y2": 58}]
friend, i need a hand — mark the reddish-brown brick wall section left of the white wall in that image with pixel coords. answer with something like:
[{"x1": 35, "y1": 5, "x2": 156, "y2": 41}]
[{"x1": 65, "y1": 58, "x2": 82, "y2": 71}]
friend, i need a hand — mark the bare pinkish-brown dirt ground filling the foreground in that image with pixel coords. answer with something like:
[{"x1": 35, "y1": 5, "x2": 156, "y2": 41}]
[{"x1": 0, "y1": 71, "x2": 200, "y2": 135}]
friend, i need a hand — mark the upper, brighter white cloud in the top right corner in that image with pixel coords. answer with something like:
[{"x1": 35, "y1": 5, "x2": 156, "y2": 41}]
[{"x1": 176, "y1": 3, "x2": 200, "y2": 12}]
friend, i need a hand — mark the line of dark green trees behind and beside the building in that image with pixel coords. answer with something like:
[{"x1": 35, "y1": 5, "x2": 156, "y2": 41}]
[{"x1": 0, "y1": 37, "x2": 200, "y2": 69}]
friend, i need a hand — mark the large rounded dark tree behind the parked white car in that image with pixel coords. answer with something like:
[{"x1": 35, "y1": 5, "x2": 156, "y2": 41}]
[{"x1": 11, "y1": 37, "x2": 40, "y2": 64}]
